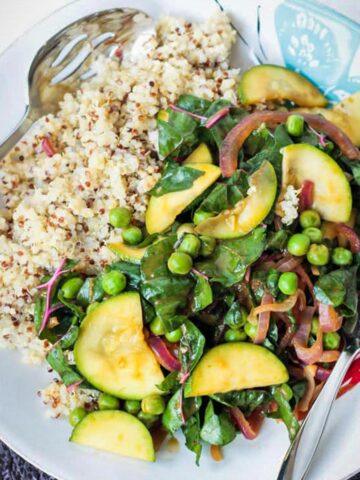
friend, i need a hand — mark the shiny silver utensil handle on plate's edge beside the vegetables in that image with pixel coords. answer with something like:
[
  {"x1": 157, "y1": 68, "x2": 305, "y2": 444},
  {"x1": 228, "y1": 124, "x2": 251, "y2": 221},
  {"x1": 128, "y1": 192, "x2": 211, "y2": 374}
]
[{"x1": 277, "y1": 351, "x2": 359, "y2": 480}]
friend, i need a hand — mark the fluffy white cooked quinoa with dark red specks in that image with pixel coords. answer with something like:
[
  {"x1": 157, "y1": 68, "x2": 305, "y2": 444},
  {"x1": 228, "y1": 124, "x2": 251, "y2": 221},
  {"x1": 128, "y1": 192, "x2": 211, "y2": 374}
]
[{"x1": 0, "y1": 12, "x2": 239, "y2": 416}]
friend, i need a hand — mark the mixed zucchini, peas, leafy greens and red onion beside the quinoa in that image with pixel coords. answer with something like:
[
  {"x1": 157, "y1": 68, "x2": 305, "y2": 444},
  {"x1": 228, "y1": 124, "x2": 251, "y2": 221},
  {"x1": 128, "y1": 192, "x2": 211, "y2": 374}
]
[{"x1": 35, "y1": 66, "x2": 360, "y2": 463}]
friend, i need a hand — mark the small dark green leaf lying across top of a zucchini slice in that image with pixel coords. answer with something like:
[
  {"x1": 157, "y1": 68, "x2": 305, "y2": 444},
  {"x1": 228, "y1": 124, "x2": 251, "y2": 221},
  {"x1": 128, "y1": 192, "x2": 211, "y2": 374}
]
[{"x1": 149, "y1": 160, "x2": 204, "y2": 197}]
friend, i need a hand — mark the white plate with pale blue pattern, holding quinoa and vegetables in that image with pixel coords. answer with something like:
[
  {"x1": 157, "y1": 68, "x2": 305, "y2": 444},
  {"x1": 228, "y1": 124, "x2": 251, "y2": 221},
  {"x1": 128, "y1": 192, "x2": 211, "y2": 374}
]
[{"x1": 0, "y1": 0, "x2": 360, "y2": 480}]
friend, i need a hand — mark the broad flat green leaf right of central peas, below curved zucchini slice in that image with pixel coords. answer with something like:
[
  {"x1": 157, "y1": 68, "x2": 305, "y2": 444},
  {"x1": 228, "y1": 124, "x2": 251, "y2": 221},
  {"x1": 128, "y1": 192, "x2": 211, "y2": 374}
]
[{"x1": 196, "y1": 227, "x2": 266, "y2": 287}]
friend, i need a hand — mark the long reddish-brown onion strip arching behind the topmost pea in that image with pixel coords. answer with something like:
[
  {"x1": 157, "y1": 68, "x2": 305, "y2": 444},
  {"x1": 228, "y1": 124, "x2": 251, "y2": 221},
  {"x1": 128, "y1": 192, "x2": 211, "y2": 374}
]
[{"x1": 220, "y1": 110, "x2": 360, "y2": 177}]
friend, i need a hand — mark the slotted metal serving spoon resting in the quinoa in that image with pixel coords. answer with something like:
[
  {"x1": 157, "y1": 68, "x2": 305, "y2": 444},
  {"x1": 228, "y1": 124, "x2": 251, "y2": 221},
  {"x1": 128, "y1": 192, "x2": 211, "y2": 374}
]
[{"x1": 0, "y1": 8, "x2": 155, "y2": 158}]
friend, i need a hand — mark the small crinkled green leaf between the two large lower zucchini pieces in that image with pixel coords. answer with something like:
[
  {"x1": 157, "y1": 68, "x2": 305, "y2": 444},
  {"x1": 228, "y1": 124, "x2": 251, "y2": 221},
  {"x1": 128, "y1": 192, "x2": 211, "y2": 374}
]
[{"x1": 179, "y1": 320, "x2": 205, "y2": 374}]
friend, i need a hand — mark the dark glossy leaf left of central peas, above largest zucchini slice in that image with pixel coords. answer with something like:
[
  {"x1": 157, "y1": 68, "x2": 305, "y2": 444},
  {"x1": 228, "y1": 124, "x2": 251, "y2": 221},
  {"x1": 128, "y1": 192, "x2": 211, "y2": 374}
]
[{"x1": 141, "y1": 235, "x2": 193, "y2": 331}]
